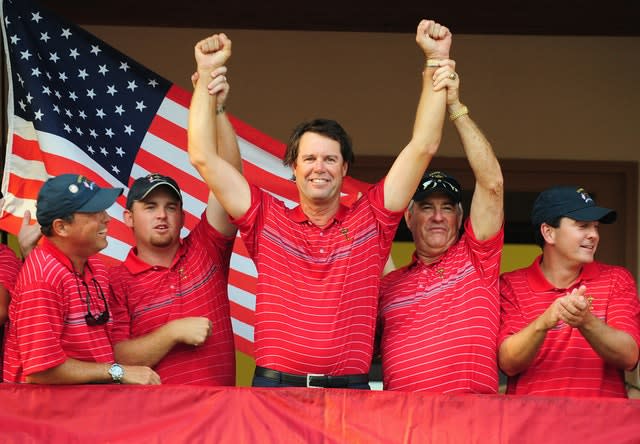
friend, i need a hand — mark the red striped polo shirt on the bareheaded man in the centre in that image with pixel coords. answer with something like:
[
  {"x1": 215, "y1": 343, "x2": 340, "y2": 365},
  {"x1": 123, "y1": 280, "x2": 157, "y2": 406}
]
[{"x1": 235, "y1": 181, "x2": 402, "y2": 375}]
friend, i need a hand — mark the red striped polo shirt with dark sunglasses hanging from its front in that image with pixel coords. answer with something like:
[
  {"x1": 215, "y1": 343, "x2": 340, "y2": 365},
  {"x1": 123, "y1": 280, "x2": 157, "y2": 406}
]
[{"x1": 4, "y1": 238, "x2": 113, "y2": 382}]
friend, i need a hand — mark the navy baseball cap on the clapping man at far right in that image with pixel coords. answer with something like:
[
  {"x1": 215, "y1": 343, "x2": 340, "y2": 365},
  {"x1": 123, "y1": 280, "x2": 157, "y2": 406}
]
[{"x1": 531, "y1": 186, "x2": 617, "y2": 226}]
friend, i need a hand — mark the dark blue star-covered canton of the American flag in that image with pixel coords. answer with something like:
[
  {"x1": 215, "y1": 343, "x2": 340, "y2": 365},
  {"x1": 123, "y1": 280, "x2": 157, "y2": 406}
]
[{"x1": 3, "y1": 0, "x2": 171, "y2": 186}]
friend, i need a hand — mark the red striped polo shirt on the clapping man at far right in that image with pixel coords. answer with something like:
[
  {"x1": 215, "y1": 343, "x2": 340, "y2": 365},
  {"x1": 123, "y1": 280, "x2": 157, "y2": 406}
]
[{"x1": 498, "y1": 256, "x2": 640, "y2": 398}]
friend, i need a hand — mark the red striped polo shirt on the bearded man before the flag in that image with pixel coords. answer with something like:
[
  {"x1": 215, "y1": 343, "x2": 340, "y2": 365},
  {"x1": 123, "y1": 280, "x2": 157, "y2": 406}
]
[{"x1": 109, "y1": 213, "x2": 236, "y2": 385}]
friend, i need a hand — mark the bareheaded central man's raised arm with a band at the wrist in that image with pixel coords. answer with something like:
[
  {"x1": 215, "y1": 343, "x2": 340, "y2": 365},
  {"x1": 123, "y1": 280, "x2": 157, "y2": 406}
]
[{"x1": 384, "y1": 20, "x2": 451, "y2": 211}]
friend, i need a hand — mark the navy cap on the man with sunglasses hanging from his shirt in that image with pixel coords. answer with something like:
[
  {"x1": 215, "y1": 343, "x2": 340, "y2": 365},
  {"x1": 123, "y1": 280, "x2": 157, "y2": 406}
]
[{"x1": 36, "y1": 174, "x2": 123, "y2": 226}]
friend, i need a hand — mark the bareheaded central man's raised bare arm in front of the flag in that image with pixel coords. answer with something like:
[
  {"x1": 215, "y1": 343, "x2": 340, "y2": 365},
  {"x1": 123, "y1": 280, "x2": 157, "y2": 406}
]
[{"x1": 188, "y1": 34, "x2": 251, "y2": 218}]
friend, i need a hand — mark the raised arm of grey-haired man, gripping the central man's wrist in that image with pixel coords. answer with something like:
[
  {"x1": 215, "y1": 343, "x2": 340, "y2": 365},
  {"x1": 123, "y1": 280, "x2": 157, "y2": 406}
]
[{"x1": 435, "y1": 60, "x2": 504, "y2": 240}]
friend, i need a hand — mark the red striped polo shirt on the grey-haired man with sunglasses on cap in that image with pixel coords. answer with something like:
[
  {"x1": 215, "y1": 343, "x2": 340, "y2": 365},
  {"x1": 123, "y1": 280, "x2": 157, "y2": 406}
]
[{"x1": 379, "y1": 219, "x2": 504, "y2": 393}]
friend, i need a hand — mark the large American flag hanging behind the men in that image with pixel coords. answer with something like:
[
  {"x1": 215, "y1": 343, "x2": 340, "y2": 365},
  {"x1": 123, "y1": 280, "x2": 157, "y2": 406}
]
[{"x1": 0, "y1": 0, "x2": 364, "y2": 355}]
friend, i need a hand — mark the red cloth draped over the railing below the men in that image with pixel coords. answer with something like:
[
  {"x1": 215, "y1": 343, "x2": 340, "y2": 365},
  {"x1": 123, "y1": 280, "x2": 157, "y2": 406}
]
[{"x1": 0, "y1": 384, "x2": 640, "y2": 444}]
